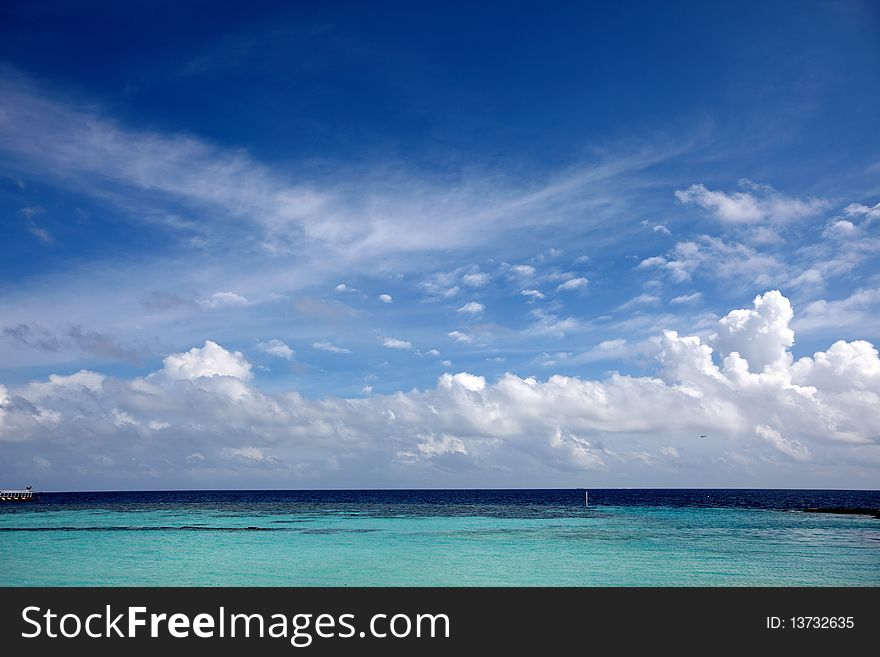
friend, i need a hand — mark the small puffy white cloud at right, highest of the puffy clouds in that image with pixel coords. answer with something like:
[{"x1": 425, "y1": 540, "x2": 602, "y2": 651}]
[{"x1": 675, "y1": 181, "x2": 828, "y2": 224}]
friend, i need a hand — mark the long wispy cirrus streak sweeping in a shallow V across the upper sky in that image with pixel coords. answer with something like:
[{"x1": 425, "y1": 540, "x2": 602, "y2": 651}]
[{"x1": 0, "y1": 70, "x2": 680, "y2": 266}]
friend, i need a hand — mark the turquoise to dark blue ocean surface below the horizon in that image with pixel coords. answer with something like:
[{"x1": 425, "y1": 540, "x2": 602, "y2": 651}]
[{"x1": 0, "y1": 489, "x2": 880, "y2": 586}]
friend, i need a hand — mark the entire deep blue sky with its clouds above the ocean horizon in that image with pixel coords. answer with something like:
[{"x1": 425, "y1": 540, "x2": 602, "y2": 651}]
[{"x1": 0, "y1": 2, "x2": 880, "y2": 488}]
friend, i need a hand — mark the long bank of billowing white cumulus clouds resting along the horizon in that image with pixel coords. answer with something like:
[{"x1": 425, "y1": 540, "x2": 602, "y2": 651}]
[{"x1": 0, "y1": 291, "x2": 880, "y2": 486}]
